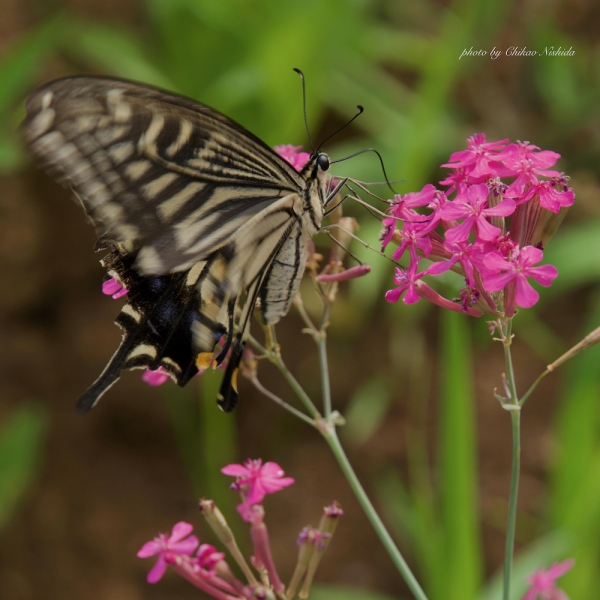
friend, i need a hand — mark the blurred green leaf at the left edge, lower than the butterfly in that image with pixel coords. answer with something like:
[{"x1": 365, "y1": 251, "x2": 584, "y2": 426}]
[{"x1": 0, "y1": 404, "x2": 48, "y2": 527}]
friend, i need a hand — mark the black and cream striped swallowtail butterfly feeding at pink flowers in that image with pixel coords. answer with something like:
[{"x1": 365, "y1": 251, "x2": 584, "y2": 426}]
[{"x1": 23, "y1": 77, "x2": 337, "y2": 412}]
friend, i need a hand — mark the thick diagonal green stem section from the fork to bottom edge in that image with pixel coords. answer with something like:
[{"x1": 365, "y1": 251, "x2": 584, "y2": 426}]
[{"x1": 319, "y1": 424, "x2": 427, "y2": 600}]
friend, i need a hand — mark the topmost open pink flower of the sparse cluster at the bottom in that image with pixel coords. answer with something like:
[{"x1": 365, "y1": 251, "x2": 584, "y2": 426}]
[{"x1": 221, "y1": 458, "x2": 294, "y2": 520}]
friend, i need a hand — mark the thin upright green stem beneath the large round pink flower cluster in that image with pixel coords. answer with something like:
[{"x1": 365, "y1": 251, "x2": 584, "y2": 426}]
[{"x1": 502, "y1": 321, "x2": 520, "y2": 600}]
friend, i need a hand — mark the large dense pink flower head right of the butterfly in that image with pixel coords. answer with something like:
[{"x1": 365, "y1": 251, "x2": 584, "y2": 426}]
[{"x1": 381, "y1": 133, "x2": 575, "y2": 317}]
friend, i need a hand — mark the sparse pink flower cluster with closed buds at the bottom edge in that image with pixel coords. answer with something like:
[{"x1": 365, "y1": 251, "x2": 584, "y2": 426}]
[{"x1": 137, "y1": 459, "x2": 344, "y2": 600}]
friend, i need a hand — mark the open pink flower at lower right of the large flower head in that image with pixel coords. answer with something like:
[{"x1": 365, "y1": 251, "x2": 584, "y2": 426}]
[{"x1": 484, "y1": 246, "x2": 558, "y2": 308}]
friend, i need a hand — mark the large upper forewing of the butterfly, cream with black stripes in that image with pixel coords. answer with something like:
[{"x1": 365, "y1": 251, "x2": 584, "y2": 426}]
[{"x1": 24, "y1": 77, "x2": 305, "y2": 275}]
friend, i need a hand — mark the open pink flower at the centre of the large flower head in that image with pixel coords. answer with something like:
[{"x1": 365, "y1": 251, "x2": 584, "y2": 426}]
[{"x1": 440, "y1": 183, "x2": 515, "y2": 242}]
